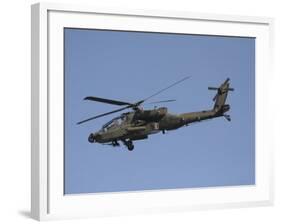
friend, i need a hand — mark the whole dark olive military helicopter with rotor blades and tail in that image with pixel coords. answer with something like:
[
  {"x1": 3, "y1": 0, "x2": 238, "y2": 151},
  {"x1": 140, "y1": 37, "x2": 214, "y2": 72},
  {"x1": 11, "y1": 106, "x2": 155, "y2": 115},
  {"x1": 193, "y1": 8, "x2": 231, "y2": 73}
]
[{"x1": 77, "y1": 77, "x2": 234, "y2": 151}]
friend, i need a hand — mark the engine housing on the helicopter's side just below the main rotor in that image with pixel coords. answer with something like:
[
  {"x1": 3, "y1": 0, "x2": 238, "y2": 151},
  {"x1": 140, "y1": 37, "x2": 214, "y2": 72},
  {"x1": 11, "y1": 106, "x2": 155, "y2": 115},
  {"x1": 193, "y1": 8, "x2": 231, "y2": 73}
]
[{"x1": 134, "y1": 107, "x2": 168, "y2": 122}]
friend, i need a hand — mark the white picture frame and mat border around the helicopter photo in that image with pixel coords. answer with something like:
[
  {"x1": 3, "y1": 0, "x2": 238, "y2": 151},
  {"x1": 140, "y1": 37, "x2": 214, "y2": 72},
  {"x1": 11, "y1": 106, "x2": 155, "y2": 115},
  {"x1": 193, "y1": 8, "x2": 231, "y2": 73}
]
[{"x1": 31, "y1": 3, "x2": 273, "y2": 220}]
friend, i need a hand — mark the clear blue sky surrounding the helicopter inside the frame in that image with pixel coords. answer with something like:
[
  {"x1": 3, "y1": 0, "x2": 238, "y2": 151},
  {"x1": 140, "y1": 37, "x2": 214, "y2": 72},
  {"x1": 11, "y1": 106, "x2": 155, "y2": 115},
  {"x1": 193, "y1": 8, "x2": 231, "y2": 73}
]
[{"x1": 65, "y1": 29, "x2": 255, "y2": 194}]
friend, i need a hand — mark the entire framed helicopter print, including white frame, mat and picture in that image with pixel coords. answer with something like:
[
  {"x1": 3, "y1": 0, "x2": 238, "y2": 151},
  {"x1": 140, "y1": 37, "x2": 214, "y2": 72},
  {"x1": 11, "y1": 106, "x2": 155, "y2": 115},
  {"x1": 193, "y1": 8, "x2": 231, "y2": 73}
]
[{"x1": 31, "y1": 3, "x2": 273, "y2": 220}]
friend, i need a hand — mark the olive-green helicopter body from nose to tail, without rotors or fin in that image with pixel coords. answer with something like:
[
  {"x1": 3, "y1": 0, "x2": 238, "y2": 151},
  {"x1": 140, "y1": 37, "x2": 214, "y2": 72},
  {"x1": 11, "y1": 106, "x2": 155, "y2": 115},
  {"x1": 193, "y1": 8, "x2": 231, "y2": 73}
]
[{"x1": 89, "y1": 105, "x2": 229, "y2": 143}]
